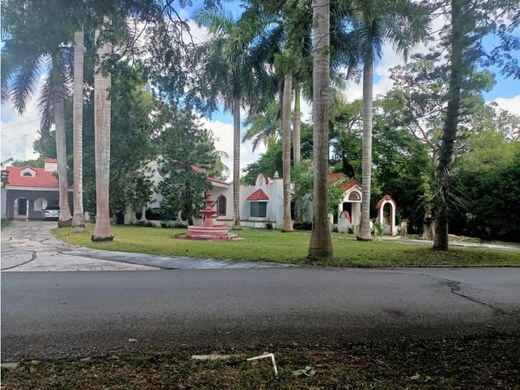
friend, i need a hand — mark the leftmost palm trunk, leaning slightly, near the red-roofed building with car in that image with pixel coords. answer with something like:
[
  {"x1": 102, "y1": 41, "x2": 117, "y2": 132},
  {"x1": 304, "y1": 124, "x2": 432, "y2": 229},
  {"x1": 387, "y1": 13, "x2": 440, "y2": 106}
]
[{"x1": 54, "y1": 81, "x2": 72, "y2": 227}]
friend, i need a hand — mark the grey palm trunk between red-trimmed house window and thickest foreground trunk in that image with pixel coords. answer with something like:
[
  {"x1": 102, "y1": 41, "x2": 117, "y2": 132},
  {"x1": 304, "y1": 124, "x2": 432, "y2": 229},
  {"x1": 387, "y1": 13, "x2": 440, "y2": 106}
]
[{"x1": 282, "y1": 74, "x2": 293, "y2": 232}]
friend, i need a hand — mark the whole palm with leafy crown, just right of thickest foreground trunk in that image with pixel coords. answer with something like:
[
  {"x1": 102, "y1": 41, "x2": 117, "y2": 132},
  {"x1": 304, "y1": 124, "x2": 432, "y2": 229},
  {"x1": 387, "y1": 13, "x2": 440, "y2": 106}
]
[{"x1": 348, "y1": 0, "x2": 428, "y2": 241}]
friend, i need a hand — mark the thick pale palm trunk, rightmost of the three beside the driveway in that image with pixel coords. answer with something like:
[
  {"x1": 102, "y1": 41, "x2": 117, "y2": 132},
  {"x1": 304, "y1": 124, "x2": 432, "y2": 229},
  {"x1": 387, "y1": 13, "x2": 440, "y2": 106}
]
[{"x1": 92, "y1": 31, "x2": 114, "y2": 241}]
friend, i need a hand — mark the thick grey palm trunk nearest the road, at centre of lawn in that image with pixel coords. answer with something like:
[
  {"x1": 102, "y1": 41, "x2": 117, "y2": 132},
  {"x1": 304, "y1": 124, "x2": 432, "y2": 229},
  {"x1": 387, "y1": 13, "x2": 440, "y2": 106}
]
[{"x1": 309, "y1": 0, "x2": 333, "y2": 260}]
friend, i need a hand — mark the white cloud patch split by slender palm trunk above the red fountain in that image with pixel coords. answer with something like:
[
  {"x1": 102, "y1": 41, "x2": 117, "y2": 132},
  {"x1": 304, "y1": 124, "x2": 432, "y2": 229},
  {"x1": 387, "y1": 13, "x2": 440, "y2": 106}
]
[{"x1": 201, "y1": 118, "x2": 266, "y2": 177}]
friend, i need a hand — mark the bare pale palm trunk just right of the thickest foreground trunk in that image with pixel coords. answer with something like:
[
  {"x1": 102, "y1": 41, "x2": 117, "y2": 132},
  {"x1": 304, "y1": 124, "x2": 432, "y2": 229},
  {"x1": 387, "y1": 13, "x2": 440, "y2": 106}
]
[{"x1": 357, "y1": 53, "x2": 374, "y2": 241}]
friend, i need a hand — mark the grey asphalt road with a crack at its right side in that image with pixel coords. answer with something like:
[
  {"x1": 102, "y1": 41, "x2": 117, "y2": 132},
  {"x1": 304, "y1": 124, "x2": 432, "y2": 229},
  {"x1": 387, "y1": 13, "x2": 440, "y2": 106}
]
[{"x1": 1, "y1": 268, "x2": 520, "y2": 361}]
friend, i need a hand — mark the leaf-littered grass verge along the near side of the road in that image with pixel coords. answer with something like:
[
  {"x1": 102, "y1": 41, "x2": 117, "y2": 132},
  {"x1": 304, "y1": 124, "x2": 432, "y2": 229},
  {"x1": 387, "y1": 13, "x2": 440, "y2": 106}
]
[{"x1": 2, "y1": 334, "x2": 520, "y2": 389}]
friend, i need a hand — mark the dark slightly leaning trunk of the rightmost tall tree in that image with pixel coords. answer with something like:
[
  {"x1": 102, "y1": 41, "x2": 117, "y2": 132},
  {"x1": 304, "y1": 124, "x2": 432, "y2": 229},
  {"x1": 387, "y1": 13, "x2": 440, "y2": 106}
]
[{"x1": 433, "y1": 0, "x2": 465, "y2": 250}]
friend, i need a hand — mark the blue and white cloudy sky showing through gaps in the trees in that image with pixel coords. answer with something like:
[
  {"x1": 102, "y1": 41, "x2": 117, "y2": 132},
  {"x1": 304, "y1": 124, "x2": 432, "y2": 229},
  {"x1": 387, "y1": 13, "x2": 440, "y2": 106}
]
[{"x1": 0, "y1": 1, "x2": 520, "y2": 172}]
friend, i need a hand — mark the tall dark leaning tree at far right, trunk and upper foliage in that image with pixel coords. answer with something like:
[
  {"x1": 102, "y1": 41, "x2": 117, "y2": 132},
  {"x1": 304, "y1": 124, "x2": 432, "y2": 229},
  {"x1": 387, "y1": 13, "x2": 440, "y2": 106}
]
[{"x1": 433, "y1": 0, "x2": 520, "y2": 250}]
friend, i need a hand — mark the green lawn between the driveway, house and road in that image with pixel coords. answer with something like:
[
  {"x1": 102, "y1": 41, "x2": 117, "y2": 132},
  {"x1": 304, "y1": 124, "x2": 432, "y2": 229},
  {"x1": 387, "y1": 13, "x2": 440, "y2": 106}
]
[{"x1": 54, "y1": 226, "x2": 520, "y2": 267}]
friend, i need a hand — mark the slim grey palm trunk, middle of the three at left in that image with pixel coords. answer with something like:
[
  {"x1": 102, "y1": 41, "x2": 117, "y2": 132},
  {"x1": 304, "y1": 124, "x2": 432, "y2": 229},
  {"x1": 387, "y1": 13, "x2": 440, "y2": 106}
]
[{"x1": 72, "y1": 28, "x2": 85, "y2": 232}]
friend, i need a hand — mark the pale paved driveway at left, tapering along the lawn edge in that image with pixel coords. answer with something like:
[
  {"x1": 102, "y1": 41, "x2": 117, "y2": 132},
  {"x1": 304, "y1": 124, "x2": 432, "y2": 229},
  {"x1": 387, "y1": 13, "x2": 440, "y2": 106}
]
[{"x1": 1, "y1": 221, "x2": 290, "y2": 272}]
